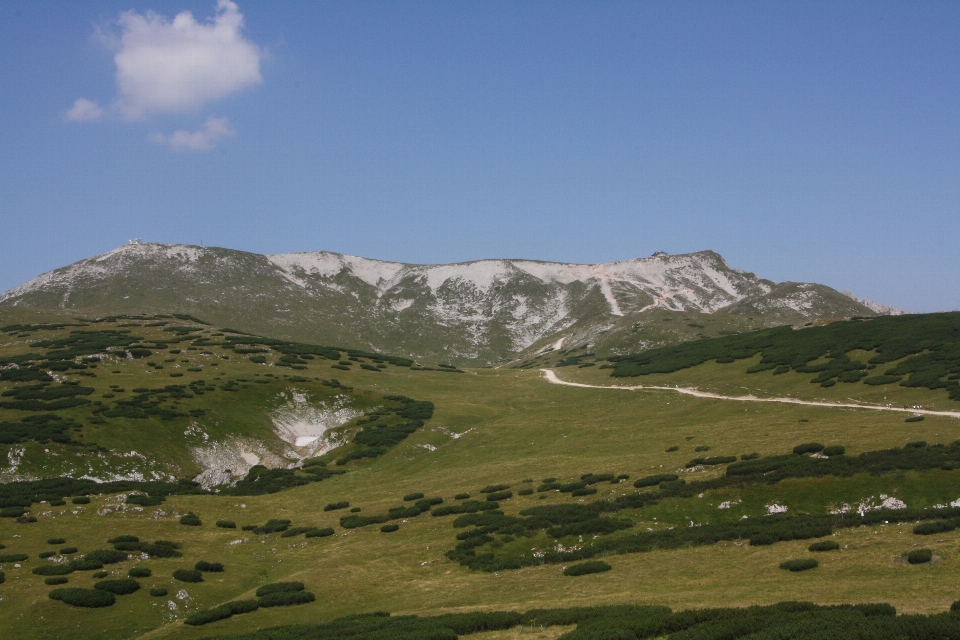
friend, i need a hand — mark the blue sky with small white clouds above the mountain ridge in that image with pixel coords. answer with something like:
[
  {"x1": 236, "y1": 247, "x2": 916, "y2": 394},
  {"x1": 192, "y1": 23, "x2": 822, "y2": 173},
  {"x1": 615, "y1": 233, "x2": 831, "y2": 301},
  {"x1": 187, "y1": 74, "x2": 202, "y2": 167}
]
[{"x1": 0, "y1": 0, "x2": 960, "y2": 311}]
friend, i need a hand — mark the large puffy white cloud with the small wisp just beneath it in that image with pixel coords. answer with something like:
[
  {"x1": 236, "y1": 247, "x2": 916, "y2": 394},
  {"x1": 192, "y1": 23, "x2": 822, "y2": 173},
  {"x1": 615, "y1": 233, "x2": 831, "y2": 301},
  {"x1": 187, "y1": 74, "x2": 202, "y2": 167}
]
[{"x1": 112, "y1": 0, "x2": 262, "y2": 119}]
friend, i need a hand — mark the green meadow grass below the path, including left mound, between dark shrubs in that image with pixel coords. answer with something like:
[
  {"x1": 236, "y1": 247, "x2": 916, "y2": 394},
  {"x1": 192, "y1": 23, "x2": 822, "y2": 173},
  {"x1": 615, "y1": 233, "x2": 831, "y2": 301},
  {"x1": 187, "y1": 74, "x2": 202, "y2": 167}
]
[{"x1": 0, "y1": 310, "x2": 960, "y2": 639}]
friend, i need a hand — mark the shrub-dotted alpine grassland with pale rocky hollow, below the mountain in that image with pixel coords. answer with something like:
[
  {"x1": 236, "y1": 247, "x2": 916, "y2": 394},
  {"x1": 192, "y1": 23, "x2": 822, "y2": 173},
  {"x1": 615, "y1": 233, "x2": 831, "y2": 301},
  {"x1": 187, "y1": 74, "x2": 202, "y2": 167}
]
[{"x1": 0, "y1": 307, "x2": 960, "y2": 640}]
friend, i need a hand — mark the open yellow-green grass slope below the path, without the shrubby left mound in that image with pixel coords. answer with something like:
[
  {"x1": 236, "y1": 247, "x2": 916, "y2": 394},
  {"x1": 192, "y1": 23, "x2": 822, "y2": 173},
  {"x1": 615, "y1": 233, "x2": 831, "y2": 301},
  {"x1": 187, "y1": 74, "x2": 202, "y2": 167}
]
[{"x1": 0, "y1": 308, "x2": 960, "y2": 638}]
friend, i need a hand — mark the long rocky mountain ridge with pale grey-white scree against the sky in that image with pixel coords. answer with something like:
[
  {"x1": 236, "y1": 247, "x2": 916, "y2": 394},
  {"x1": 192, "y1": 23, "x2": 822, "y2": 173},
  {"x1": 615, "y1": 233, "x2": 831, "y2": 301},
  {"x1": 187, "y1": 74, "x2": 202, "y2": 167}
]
[{"x1": 0, "y1": 243, "x2": 875, "y2": 365}]
